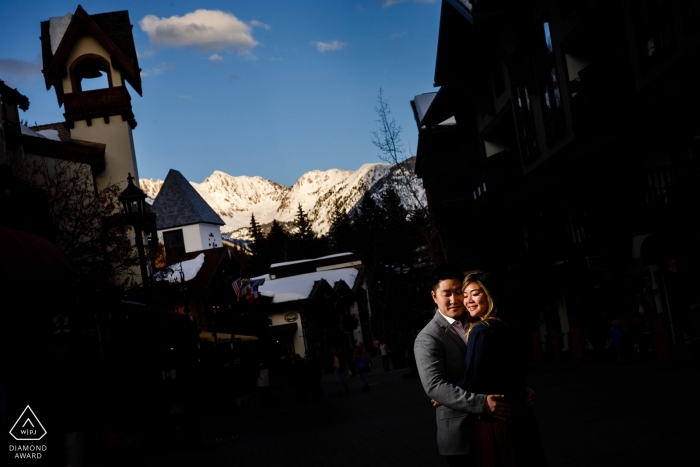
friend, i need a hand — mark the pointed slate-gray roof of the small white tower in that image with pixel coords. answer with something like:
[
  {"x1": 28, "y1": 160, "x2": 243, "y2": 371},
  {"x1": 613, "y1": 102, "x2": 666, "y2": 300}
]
[{"x1": 151, "y1": 169, "x2": 225, "y2": 230}]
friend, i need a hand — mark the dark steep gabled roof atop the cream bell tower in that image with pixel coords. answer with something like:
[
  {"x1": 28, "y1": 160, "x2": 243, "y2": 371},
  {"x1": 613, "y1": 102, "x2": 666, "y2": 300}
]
[{"x1": 40, "y1": 5, "x2": 142, "y2": 100}]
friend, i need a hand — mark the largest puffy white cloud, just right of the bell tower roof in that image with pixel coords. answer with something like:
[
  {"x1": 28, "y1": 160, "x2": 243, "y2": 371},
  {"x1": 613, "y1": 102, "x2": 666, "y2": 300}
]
[{"x1": 139, "y1": 10, "x2": 258, "y2": 54}]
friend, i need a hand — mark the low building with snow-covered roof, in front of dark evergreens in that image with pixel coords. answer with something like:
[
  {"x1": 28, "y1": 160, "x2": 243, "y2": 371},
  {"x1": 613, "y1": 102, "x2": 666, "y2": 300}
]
[{"x1": 253, "y1": 253, "x2": 372, "y2": 356}]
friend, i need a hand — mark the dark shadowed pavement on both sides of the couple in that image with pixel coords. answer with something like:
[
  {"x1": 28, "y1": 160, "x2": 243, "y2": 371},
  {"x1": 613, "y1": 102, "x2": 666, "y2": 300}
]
[{"x1": 143, "y1": 359, "x2": 700, "y2": 467}]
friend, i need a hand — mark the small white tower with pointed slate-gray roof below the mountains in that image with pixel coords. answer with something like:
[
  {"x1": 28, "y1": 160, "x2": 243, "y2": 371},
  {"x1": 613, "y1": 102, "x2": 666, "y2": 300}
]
[{"x1": 151, "y1": 169, "x2": 225, "y2": 262}]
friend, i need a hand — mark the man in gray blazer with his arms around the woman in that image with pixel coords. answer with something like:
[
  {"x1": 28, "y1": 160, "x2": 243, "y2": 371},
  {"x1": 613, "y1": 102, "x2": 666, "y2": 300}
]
[{"x1": 414, "y1": 265, "x2": 510, "y2": 467}]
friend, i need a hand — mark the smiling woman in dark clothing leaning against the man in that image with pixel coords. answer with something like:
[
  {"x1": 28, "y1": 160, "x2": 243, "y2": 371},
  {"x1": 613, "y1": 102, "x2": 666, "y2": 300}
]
[{"x1": 459, "y1": 272, "x2": 546, "y2": 467}]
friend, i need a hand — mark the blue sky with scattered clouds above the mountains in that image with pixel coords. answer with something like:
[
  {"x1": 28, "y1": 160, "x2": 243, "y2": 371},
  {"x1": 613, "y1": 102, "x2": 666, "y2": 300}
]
[{"x1": 0, "y1": 0, "x2": 440, "y2": 185}]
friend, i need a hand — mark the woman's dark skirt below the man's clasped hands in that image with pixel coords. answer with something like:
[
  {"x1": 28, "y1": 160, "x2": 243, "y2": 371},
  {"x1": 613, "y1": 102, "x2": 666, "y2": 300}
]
[{"x1": 474, "y1": 407, "x2": 547, "y2": 467}]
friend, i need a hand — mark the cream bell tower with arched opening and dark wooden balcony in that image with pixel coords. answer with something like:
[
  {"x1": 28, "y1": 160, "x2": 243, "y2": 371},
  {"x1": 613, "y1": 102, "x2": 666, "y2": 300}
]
[{"x1": 41, "y1": 5, "x2": 142, "y2": 189}]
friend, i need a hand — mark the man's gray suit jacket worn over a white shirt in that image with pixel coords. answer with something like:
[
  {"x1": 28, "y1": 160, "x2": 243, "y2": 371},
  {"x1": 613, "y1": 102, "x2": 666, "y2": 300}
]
[{"x1": 414, "y1": 311, "x2": 486, "y2": 456}]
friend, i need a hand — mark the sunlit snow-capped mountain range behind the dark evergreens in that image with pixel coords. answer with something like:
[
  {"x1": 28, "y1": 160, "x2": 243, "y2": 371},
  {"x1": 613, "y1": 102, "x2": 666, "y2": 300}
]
[{"x1": 139, "y1": 159, "x2": 426, "y2": 238}]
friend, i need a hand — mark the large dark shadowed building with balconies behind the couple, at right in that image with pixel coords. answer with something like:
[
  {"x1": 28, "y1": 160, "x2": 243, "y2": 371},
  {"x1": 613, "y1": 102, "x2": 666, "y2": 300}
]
[{"x1": 412, "y1": 0, "x2": 700, "y2": 358}]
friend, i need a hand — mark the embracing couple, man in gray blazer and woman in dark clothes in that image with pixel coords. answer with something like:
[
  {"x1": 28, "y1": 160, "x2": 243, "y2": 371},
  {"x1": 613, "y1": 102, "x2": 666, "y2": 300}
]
[{"x1": 414, "y1": 265, "x2": 546, "y2": 467}]
